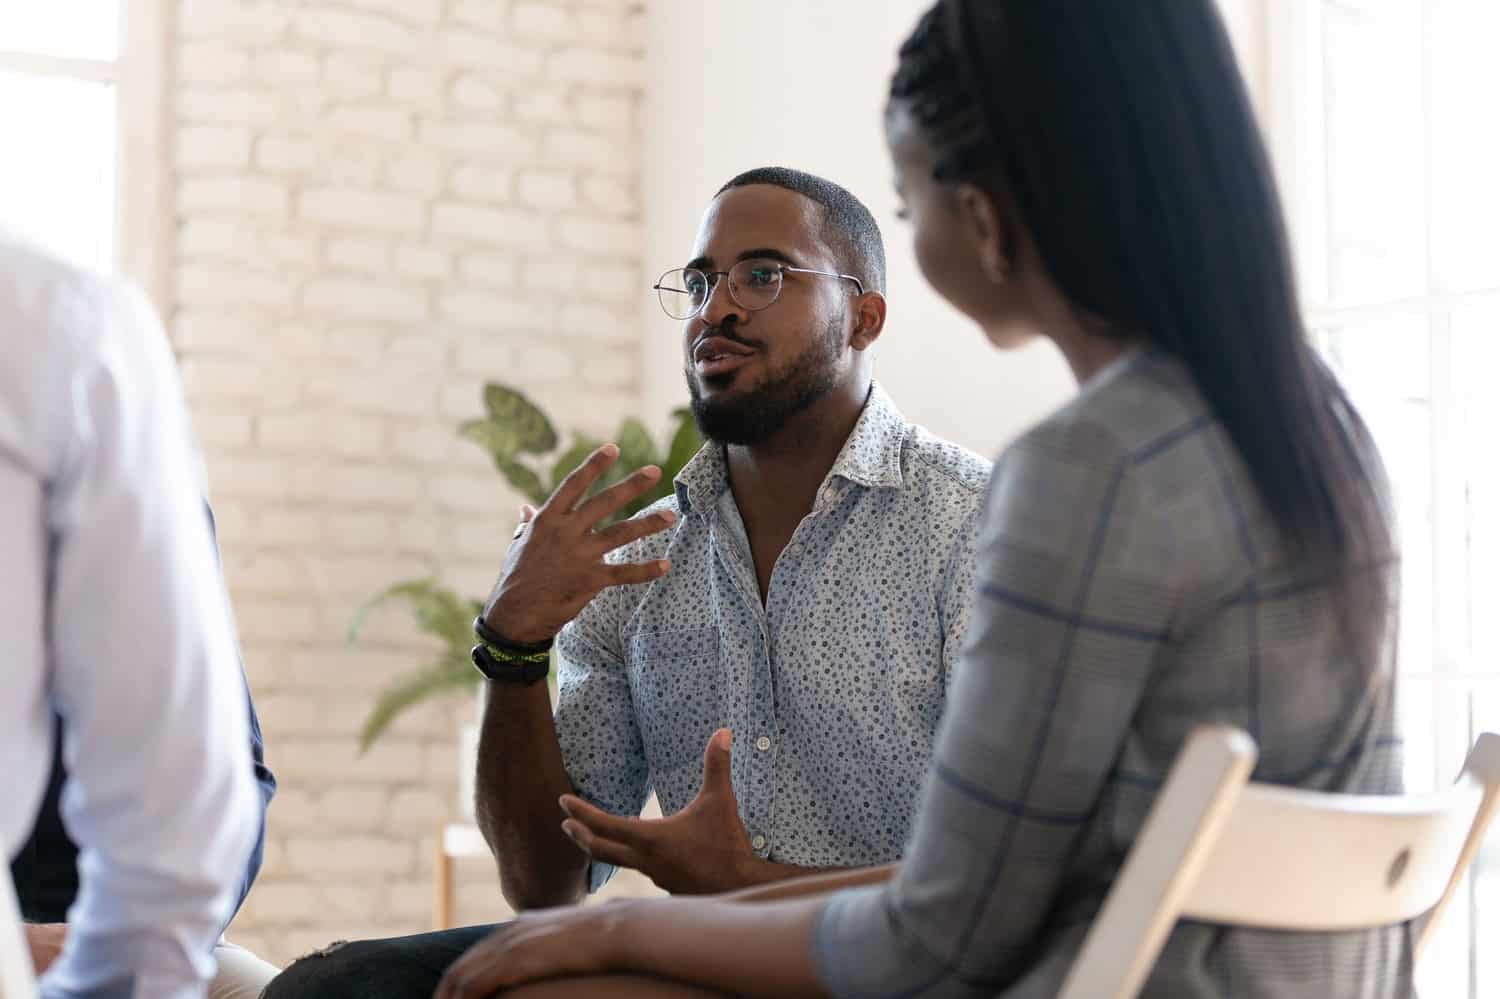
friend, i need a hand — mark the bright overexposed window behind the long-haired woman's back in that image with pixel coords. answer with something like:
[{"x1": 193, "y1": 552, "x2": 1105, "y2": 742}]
[{"x1": 1266, "y1": 0, "x2": 1500, "y2": 999}]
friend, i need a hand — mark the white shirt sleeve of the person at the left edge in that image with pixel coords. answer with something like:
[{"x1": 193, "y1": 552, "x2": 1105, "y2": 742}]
[{"x1": 44, "y1": 274, "x2": 260, "y2": 999}]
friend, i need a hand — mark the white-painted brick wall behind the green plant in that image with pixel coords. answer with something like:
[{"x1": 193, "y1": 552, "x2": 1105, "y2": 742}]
[{"x1": 171, "y1": 0, "x2": 653, "y2": 962}]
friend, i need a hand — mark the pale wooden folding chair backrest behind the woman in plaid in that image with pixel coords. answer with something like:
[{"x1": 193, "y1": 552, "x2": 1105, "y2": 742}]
[{"x1": 1061, "y1": 726, "x2": 1500, "y2": 999}]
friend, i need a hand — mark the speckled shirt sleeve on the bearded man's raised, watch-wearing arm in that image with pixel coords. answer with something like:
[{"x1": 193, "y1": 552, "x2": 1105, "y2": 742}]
[{"x1": 555, "y1": 579, "x2": 651, "y2": 891}]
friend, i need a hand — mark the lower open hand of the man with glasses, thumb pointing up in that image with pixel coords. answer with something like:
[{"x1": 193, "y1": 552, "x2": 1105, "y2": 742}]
[{"x1": 563, "y1": 729, "x2": 764, "y2": 896}]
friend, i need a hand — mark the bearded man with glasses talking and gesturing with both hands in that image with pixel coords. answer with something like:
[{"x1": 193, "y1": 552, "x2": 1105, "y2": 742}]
[{"x1": 266, "y1": 168, "x2": 989, "y2": 999}]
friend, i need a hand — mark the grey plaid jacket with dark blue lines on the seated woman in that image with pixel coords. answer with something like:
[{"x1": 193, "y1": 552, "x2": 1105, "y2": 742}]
[{"x1": 815, "y1": 353, "x2": 1412, "y2": 999}]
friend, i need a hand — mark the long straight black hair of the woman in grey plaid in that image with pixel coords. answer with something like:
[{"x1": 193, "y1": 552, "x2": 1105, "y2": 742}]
[{"x1": 891, "y1": 0, "x2": 1394, "y2": 648}]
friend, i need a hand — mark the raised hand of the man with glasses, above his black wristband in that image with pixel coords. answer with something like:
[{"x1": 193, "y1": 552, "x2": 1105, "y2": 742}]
[{"x1": 485, "y1": 444, "x2": 677, "y2": 644}]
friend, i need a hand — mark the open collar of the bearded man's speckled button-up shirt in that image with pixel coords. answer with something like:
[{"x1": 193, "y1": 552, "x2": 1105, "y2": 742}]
[{"x1": 674, "y1": 383, "x2": 906, "y2": 516}]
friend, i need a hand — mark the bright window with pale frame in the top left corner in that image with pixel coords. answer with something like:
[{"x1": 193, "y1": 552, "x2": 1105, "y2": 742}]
[{"x1": 0, "y1": 0, "x2": 171, "y2": 308}]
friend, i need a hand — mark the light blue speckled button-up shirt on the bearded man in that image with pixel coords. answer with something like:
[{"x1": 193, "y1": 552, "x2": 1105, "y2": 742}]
[{"x1": 557, "y1": 386, "x2": 990, "y2": 887}]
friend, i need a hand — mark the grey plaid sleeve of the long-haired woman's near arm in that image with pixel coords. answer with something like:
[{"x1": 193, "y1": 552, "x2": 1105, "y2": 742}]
[{"x1": 815, "y1": 411, "x2": 1176, "y2": 996}]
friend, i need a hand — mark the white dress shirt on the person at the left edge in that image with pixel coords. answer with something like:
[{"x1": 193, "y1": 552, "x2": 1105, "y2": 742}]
[{"x1": 0, "y1": 234, "x2": 260, "y2": 999}]
